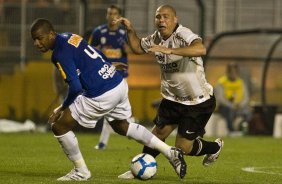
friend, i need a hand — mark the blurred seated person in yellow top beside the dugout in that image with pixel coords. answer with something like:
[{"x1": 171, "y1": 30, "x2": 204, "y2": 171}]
[{"x1": 215, "y1": 63, "x2": 250, "y2": 134}]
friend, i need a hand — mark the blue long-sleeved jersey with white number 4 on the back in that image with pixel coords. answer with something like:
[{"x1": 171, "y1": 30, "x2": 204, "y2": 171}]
[{"x1": 52, "y1": 33, "x2": 122, "y2": 107}]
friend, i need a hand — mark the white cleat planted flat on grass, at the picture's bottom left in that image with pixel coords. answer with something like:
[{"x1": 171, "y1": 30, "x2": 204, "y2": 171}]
[{"x1": 57, "y1": 168, "x2": 91, "y2": 181}]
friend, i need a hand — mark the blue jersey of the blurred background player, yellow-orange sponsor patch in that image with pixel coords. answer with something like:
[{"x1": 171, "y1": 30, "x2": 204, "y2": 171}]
[{"x1": 89, "y1": 24, "x2": 128, "y2": 77}]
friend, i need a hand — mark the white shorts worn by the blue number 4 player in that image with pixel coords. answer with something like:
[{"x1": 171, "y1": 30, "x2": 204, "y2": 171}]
[{"x1": 69, "y1": 80, "x2": 132, "y2": 128}]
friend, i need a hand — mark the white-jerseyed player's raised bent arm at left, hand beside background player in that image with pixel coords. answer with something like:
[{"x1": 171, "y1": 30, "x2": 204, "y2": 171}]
[{"x1": 115, "y1": 17, "x2": 145, "y2": 54}]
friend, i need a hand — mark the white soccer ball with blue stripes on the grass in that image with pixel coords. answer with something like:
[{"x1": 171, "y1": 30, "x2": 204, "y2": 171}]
[{"x1": 130, "y1": 153, "x2": 157, "y2": 180}]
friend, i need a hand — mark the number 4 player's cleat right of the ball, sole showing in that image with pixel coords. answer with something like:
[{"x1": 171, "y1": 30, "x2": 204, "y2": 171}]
[{"x1": 169, "y1": 147, "x2": 187, "y2": 179}]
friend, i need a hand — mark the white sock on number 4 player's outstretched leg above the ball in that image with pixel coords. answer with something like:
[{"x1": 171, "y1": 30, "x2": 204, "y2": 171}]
[{"x1": 126, "y1": 123, "x2": 171, "y2": 158}]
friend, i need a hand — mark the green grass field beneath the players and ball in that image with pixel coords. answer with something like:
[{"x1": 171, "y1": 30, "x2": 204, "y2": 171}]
[{"x1": 0, "y1": 133, "x2": 282, "y2": 184}]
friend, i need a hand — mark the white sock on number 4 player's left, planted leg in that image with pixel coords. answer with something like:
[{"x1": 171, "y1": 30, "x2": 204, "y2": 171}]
[{"x1": 55, "y1": 131, "x2": 88, "y2": 171}]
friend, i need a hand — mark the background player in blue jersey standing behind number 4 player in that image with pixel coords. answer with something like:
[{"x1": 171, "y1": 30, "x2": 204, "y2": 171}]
[{"x1": 89, "y1": 5, "x2": 130, "y2": 149}]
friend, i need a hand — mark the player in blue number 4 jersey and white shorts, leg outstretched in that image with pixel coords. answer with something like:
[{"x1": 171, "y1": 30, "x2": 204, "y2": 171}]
[{"x1": 30, "y1": 19, "x2": 186, "y2": 181}]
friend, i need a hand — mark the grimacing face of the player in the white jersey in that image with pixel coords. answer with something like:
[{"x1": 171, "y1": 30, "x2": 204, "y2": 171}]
[{"x1": 155, "y1": 7, "x2": 177, "y2": 39}]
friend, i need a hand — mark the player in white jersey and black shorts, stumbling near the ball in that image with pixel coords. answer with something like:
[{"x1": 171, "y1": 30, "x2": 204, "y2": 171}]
[{"x1": 116, "y1": 5, "x2": 223, "y2": 179}]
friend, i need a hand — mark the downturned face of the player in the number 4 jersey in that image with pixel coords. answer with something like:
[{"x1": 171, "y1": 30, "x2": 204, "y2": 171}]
[{"x1": 31, "y1": 29, "x2": 55, "y2": 52}]
